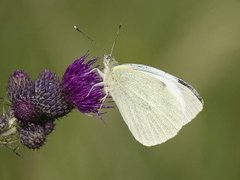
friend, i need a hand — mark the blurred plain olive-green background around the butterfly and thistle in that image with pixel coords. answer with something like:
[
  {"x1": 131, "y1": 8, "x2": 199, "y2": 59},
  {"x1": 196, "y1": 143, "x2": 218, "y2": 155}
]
[{"x1": 0, "y1": 0, "x2": 240, "y2": 180}]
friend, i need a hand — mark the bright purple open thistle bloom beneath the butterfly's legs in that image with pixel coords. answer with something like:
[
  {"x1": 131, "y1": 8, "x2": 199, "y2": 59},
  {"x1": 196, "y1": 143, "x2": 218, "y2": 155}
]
[{"x1": 63, "y1": 54, "x2": 105, "y2": 113}]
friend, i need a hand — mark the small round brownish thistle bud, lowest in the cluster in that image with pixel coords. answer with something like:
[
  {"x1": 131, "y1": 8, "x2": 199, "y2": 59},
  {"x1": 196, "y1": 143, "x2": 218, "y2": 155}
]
[{"x1": 20, "y1": 123, "x2": 46, "y2": 149}]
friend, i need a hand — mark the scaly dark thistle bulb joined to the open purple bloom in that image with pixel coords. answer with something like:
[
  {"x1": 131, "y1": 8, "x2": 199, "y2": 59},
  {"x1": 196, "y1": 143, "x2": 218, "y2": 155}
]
[{"x1": 33, "y1": 70, "x2": 73, "y2": 119}]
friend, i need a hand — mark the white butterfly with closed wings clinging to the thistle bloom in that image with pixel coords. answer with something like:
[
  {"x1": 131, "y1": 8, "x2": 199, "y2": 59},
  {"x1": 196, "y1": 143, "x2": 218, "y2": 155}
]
[{"x1": 94, "y1": 55, "x2": 203, "y2": 146}]
